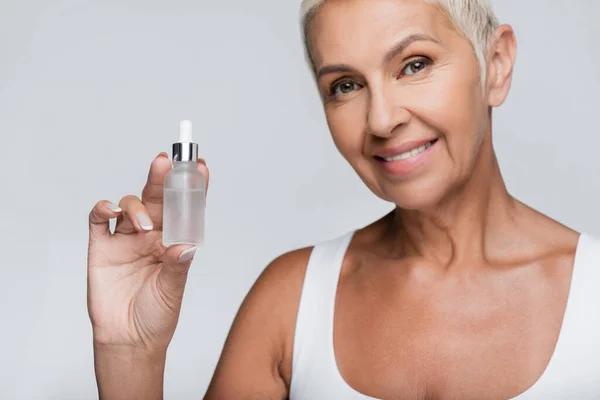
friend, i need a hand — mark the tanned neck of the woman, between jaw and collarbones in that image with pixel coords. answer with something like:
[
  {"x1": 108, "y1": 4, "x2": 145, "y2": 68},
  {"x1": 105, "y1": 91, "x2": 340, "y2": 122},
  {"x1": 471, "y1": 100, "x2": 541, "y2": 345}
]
[{"x1": 392, "y1": 134, "x2": 517, "y2": 267}]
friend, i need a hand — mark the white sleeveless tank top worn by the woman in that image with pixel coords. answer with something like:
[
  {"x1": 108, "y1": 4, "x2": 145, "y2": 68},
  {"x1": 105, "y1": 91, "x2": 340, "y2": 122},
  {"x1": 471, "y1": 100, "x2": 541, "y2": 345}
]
[{"x1": 290, "y1": 231, "x2": 600, "y2": 400}]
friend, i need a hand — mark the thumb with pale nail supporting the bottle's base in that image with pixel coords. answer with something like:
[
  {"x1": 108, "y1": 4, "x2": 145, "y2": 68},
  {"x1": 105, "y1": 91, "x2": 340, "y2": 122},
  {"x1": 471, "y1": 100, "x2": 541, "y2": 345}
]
[{"x1": 158, "y1": 245, "x2": 197, "y2": 309}]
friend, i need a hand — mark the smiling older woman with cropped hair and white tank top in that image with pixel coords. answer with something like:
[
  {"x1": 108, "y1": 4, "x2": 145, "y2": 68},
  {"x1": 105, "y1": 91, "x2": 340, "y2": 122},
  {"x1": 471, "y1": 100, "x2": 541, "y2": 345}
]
[{"x1": 88, "y1": 0, "x2": 600, "y2": 400}]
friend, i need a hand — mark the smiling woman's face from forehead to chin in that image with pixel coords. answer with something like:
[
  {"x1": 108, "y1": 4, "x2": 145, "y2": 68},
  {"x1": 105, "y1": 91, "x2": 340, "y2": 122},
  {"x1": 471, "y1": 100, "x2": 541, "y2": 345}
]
[{"x1": 309, "y1": 0, "x2": 496, "y2": 209}]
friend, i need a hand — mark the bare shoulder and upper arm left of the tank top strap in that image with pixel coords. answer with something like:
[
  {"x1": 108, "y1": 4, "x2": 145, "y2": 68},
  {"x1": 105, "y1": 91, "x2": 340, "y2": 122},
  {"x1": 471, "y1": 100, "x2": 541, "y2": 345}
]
[{"x1": 205, "y1": 248, "x2": 310, "y2": 400}]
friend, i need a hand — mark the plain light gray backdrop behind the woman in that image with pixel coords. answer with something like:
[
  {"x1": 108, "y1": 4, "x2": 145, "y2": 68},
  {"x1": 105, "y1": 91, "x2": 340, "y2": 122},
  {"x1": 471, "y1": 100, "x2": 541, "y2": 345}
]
[{"x1": 0, "y1": 0, "x2": 600, "y2": 400}]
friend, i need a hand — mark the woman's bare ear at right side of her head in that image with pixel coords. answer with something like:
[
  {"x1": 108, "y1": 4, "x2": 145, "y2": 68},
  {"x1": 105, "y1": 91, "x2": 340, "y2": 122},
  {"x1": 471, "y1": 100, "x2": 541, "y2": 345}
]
[{"x1": 486, "y1": 25, "x2": 517, "y2": 107}]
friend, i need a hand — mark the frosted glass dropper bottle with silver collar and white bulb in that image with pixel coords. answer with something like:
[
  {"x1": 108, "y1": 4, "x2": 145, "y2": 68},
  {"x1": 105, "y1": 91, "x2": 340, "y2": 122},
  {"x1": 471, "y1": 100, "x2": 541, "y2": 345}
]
[{"x1": 163, "y1": 121, "x2": 206, "y2": 247}]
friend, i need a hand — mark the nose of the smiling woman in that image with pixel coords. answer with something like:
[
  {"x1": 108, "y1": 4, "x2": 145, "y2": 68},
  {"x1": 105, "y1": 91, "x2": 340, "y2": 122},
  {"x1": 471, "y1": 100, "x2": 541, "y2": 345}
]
[{"x1": 367, "y1": 89, "x2": 411, "y2": 138}]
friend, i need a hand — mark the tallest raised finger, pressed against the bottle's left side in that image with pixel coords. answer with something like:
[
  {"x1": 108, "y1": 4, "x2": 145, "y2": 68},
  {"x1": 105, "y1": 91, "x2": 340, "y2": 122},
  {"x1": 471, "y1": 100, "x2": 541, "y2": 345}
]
[{"x1": 142, "y1": 153, "x2": 171, "y2": 229}]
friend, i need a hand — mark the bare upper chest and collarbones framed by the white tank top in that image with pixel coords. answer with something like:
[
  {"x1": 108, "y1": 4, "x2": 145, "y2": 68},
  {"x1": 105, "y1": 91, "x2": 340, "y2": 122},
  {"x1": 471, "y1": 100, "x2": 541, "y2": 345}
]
[{"x1": 334, "y1": 209, "x2": 576, "y2": 399}]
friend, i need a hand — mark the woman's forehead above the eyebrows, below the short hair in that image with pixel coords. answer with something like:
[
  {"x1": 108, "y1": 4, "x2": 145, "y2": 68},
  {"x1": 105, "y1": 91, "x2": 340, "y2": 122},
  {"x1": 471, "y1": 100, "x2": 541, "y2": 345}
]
[{"x1": 308, "y1": 0, "x2": 451, "y2": 68}]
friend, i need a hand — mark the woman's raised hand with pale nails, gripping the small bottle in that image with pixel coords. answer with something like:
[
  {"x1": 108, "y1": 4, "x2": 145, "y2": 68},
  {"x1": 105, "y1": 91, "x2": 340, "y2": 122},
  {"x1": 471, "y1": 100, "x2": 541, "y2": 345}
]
[{"x1": 88, "y1": 153, "x2": 208, "y2": 354}]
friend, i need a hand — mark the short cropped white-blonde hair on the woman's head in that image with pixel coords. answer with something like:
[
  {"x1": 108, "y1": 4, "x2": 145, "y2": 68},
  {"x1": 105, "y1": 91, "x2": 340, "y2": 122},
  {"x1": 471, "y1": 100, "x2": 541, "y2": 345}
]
[{"x1": 300, "y1": 0, "x2": 499, "y2": 81}]
